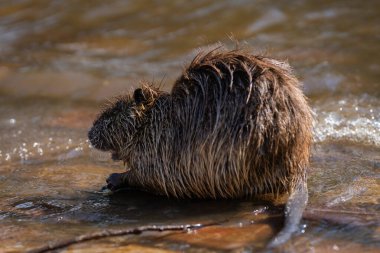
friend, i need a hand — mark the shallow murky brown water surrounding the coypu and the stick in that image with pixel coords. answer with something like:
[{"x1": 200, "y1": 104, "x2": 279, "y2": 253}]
[{"x1": 0, "y1": 0, "x2": 380, "y2": 252}]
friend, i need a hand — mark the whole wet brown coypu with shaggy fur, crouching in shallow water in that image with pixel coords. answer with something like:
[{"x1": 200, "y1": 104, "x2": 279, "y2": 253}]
[{"x1": 88, "y1": 48, "x2": 312, "y2": 246}]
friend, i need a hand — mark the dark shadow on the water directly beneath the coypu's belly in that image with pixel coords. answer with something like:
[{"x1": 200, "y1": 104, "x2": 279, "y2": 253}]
[{"x1": 86, "y1": 189, "x2": 279, "y2": 224}]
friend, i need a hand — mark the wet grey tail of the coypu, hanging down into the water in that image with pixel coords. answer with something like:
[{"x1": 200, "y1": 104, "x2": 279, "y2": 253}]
[{"x1": 268, "y1": 179, "x2": 308, "y2": 248}]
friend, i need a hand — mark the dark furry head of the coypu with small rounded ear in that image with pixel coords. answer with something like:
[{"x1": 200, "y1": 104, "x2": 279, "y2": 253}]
[{"x1": 88, "y1": 87, "x2": 157, "y2": 160}]
